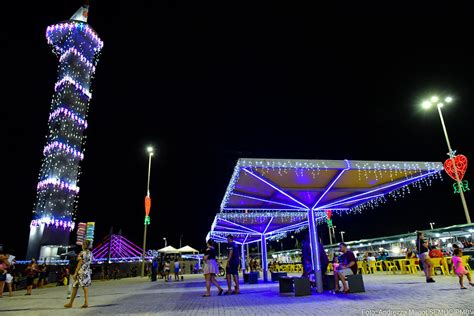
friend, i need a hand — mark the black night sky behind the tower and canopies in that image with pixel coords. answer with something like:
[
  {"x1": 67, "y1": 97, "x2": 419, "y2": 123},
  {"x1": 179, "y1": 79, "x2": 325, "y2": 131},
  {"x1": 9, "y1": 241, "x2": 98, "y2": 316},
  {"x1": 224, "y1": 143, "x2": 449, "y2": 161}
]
[{"x1": 0, "y1": 0, "x2": 474, "y2": 257}]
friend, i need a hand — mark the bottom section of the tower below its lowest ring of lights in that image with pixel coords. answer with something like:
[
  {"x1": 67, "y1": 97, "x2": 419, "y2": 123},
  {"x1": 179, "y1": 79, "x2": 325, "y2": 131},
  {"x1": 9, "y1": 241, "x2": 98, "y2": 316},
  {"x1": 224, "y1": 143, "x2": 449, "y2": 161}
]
[{"x1": 26, "y1": 225, "x2": 70, "y2": 262}]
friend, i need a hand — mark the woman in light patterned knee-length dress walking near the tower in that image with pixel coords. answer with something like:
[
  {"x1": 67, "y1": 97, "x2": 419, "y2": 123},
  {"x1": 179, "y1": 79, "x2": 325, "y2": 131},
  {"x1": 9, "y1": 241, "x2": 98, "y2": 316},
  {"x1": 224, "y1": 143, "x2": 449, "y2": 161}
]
[{"x1": 64, "y1": 239, "x2": 93, "y2": 308}]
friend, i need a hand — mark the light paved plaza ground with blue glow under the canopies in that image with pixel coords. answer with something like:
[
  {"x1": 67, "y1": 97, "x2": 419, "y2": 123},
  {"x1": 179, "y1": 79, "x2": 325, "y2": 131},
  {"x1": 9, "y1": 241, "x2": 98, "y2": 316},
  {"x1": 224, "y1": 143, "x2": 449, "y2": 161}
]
[{"x1": 0, "y1": 273, "x2": 474, "y2": 316}]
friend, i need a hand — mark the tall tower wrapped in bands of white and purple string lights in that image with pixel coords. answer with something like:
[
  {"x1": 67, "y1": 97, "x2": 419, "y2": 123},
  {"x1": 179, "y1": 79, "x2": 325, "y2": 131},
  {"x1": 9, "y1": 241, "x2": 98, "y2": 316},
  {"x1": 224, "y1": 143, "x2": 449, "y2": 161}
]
[{"x1": 27, "y1": 2, "x2": 103, "y2": 258}]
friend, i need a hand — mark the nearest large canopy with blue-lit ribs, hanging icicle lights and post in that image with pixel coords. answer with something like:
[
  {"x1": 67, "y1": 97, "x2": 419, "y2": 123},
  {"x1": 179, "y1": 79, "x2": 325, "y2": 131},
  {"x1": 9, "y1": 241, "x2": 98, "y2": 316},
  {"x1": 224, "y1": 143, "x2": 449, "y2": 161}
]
[{"x1": 217, "y1": 158, "x2": 443, "y2": 292}]
